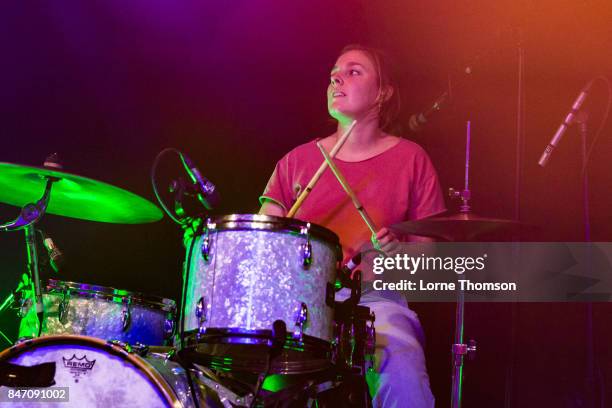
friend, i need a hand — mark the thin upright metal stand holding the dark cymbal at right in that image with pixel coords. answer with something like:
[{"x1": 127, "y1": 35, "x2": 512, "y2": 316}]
[{"x1": 449, "y1": 120, "x2": 476, "y2": 408}]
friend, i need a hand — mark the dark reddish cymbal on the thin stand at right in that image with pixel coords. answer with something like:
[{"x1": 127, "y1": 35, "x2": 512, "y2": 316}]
[{"x1": 391, "y1": 213, "x2": 528, "y2": 241}]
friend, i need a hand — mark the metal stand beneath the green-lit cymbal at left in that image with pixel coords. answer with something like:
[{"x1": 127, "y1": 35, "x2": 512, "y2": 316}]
[{"x1": 0, "y1": 177, "x2": 58, "y2": 335}]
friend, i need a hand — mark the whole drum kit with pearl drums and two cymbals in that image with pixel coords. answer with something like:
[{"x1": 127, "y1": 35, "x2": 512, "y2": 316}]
[{"x1": 0, "y1": 151, "x2": 524, "y2": 407}]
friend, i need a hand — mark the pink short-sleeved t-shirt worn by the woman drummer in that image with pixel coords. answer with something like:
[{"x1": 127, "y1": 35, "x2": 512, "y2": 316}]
[{"x1": 260, "y1": 139, "x2": 446, "y2": 260}]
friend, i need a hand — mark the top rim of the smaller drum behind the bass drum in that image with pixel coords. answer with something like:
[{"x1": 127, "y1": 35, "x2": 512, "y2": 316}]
[{"x1": 46, "y1": 279, "x2": 176, "y2": 313}]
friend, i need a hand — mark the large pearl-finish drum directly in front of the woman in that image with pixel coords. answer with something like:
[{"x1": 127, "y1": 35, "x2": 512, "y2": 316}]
[{"x1": 184, "y1": 214, "x2": 342, "y2": 373}]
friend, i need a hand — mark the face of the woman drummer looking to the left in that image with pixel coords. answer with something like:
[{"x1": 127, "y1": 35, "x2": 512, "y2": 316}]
[{"x1": 327, "y1": 50, "x2": 380, "y2": 122}]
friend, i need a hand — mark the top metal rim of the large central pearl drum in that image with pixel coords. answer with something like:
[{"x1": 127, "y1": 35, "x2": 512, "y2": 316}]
[{"x1": 204, "y1": 214, "x2": 340, "y2": 246}]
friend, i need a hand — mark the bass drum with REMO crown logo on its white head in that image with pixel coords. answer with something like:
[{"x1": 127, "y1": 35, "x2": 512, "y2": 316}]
[{"x1": 0, "y1": 336, "x2": 195, "y2": 408}]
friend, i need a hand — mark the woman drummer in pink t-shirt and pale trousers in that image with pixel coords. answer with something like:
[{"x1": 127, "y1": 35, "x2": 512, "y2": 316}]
[{"x1": 260, "y1": 45, "x2": 445, "y2": 408}]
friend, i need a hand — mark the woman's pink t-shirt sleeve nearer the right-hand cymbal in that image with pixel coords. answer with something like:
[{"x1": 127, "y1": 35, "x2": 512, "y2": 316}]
[{"x1": 408, "y1": 150, "x2": 446, "y2": 220}]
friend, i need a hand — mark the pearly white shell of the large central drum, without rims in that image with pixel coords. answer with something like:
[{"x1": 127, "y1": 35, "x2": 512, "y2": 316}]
[{"x1": 185, "y1": 216, "x2": 339, "y2": 341}]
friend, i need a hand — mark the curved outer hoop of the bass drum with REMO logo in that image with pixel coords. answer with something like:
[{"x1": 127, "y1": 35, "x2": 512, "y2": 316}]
[{"x1": 0, "y1": 335, "x2": 181, "y2": 407}]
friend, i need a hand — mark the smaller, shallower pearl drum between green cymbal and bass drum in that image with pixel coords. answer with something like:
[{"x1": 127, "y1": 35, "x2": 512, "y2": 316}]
[{"x1": 19, "y1": 279, "x2": 176, "y2": 346}]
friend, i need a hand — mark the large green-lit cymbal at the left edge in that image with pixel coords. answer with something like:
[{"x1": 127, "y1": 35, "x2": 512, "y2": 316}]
[{"x1": 0, "y1": 162, "x2": 163, "y2": 224}]
